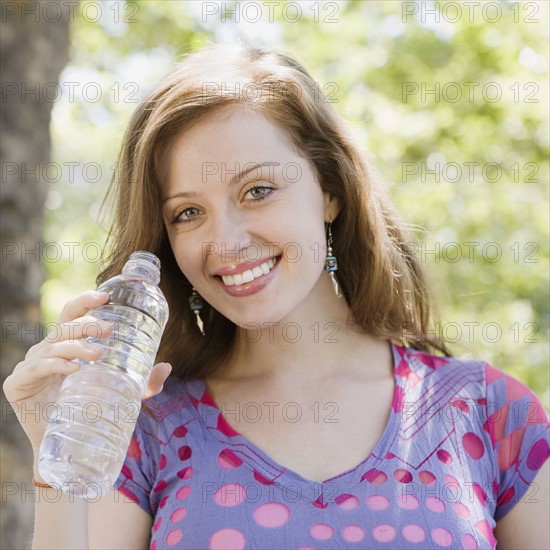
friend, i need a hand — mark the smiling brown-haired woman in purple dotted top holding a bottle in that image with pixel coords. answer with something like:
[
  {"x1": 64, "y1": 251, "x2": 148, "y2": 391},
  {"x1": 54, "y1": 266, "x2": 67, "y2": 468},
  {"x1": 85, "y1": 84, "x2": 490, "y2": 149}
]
[{"x1": 4, "y1": 46, "x2": 549, "y2": 549}]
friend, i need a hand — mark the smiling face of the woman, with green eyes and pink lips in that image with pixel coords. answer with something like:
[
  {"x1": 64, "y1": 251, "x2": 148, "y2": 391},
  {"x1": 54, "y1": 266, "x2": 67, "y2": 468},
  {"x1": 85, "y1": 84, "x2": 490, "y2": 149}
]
[{"x1": 163, "y1": 106, "x2": 338, "y2": 327}]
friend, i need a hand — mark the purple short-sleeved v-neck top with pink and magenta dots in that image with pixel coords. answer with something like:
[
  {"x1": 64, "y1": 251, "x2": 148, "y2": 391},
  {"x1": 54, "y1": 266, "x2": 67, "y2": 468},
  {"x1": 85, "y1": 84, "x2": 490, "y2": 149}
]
[{"x1": 115, "y1": 345, "x2": 549, "y2": 550}]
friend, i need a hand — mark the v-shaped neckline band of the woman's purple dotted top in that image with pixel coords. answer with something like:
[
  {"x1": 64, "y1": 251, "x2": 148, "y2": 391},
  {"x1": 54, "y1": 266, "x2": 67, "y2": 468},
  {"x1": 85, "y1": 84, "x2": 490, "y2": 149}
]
[{"x1": 185, "y1": 342, "x2": 406, "y2": 508}]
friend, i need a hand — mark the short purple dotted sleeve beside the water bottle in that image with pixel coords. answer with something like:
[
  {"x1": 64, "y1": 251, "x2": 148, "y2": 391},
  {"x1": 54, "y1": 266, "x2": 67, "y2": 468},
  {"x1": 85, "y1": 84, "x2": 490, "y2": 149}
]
[{"x1": 113, "y1": 407, "x2": 158, "y2": 516}]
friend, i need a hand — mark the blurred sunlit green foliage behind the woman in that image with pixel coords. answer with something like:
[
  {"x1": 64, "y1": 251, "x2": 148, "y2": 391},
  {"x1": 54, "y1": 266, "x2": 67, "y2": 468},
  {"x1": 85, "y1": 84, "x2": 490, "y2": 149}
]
[{"x1": 43, "y1": 1, "x2": 550, "y2": 402}]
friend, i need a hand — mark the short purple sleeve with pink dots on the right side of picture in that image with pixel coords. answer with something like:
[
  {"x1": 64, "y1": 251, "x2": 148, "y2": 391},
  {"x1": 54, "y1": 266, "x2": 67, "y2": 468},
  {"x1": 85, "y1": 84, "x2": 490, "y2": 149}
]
[{"x1": 484, "y1": 364, "x2": 550, "y2": 521}]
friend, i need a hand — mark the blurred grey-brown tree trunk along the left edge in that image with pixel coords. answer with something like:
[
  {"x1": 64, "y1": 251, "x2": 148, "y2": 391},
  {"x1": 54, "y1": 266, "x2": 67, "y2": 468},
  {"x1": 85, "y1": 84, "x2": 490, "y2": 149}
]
[{"x1": 0, "y1": 0, "x2": 69, "y2": 549}]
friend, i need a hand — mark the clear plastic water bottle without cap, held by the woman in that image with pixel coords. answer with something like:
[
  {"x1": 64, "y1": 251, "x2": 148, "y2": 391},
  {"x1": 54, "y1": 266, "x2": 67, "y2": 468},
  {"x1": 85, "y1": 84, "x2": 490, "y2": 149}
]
[{"x1": 38, "y1": 251, "x2": 168, "y2": 498}]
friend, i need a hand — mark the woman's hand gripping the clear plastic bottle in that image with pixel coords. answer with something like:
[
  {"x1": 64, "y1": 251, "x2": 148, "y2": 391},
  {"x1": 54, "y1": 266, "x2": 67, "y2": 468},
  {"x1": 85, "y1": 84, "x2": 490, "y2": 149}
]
[{"x1": 3, "y1": 290, "x2": 171, "y2": 457}]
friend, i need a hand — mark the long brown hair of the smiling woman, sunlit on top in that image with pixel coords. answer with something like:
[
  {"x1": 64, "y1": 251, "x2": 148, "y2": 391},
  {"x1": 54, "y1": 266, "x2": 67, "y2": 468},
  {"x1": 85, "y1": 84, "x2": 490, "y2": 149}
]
[{"x1": 97, "y1": 44, "x2": 449, "y2": 379}]
